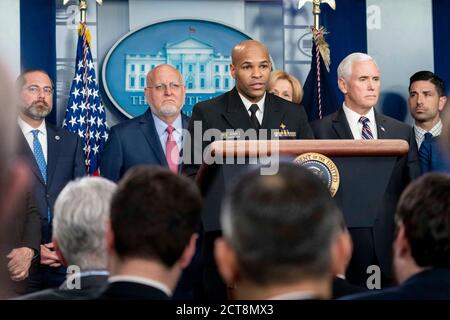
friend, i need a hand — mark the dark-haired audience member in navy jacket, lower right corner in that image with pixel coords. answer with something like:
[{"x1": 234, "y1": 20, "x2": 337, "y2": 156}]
[{"x1": 348, "y1": 173, "x2": 450, "y2": 300}]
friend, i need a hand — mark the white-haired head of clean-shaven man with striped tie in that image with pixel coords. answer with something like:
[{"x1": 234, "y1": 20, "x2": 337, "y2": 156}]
[{"x1": 337, "y1": 52, "x2": 380, "y2": 115}]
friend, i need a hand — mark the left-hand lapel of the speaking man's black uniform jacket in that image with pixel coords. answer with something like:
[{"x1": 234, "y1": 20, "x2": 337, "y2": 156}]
[{"x1": 222, "y1": 87, "x2": 252, "y2": 131}]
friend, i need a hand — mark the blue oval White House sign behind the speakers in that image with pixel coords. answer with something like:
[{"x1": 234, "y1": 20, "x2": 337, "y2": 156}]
[{"x1": 102, "y1": 19, "x2": 250, "y2": 118}]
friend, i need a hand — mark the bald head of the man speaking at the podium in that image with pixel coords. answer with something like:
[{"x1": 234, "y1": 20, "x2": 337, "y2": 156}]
[{"x1": 230, "y1": 40, "x2": 272, "y2": 103}]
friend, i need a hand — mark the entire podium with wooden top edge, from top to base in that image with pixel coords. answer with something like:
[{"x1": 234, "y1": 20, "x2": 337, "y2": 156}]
[{"x1": 196, "y1": 139, "x2": 418, "y2": 299}]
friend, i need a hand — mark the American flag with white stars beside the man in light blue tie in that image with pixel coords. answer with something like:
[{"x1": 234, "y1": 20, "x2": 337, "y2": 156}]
[{"x1": 62, "y1": 23, "x2": 109, "y2": 175}]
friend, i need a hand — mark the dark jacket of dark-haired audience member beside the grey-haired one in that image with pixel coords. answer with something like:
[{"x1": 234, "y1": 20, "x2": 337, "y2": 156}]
[{"x1": 99, "y1": 281, "x2": 170, "y2": 300}]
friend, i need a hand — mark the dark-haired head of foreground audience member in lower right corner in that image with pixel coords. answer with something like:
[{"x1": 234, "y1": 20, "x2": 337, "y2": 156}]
[{"x1": 393, "y1": 173, "x2": 450, "y2": 283}]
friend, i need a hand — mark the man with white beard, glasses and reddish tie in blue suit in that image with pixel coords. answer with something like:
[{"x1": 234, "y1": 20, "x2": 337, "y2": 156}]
[{"x1": 100, "y1": 64, "x2": 189, "y2": 181}]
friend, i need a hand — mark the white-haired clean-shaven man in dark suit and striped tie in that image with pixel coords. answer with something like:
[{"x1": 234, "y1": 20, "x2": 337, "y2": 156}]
[{"x1": 311, "y1": 53, "x2": 420, "y2": 286}]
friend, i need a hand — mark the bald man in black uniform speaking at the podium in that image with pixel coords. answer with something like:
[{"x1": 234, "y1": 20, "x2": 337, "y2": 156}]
[{"x1": 183, "y1": 40, "x2": 313, "y2": 176}]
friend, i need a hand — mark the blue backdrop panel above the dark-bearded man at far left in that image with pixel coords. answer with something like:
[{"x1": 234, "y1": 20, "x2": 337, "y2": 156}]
[{"x1": 20, "y1": 0, "x2": 56, "y2": 124}]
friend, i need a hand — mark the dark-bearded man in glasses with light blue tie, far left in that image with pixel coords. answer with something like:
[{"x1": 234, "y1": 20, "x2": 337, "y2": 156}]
[{"x1": 17, "y1": 70, "x2": 85, "y2": 291}]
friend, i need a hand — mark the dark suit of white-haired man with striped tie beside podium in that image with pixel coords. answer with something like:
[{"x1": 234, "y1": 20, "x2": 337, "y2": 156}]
[{"x1": 311, "y1": 108, "x2": 420, "y2": 285}]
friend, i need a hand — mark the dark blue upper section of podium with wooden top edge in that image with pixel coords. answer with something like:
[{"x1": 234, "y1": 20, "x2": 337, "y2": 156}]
[{"x1": 196, "y1": 140, "x2": 409, "y2": 232}]
